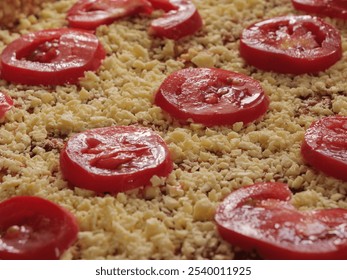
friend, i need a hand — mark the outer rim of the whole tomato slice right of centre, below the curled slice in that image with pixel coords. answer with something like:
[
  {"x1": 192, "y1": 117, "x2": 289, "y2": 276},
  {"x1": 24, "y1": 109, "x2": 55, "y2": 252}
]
[{"x1": 154, "y1": 68, "x2": 270, "y2": 126}]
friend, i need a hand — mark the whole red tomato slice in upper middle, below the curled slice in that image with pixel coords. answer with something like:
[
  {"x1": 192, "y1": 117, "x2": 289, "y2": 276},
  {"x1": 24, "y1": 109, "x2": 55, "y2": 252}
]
[{"x1": 154, "y1": 68, "x2": 269, "y2": 126}]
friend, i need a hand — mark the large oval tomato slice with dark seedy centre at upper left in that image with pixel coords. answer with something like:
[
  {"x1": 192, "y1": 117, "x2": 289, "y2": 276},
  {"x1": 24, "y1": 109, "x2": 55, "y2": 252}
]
[{"x1": 1, "y1": 28, "x2": 105, "y2": 85}]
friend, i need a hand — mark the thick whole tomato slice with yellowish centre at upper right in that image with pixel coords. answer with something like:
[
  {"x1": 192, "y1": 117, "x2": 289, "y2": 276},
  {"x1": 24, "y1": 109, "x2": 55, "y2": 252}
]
[{"x1": 240, "y1": 16, "x2": 342, "y2": 74}]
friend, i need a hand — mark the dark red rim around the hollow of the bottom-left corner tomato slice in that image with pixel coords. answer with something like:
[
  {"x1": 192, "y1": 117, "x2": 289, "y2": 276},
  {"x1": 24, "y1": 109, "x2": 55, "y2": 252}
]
[{"x1": 0, "y1": 196, "x2": 78, "y2": 259}]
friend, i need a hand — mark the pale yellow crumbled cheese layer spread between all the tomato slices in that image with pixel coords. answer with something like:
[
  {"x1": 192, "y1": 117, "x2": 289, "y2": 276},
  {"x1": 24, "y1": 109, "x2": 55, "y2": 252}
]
[{"x1": 0, "y1": 0, "x2": 347, "y2": 259}]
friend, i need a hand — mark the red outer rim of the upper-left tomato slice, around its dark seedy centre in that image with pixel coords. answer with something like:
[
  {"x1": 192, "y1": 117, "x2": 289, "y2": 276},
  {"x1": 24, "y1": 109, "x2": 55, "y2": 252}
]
[{"x1": 1, "y1": 28, "x2": 106, "y2": 85}]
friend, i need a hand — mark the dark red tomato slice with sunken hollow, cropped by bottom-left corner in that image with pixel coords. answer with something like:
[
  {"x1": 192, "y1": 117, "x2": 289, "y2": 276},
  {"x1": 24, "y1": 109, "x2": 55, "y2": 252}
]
[{"x1": 0, "y1": 196, "x2": 78, "y2": 260}]
